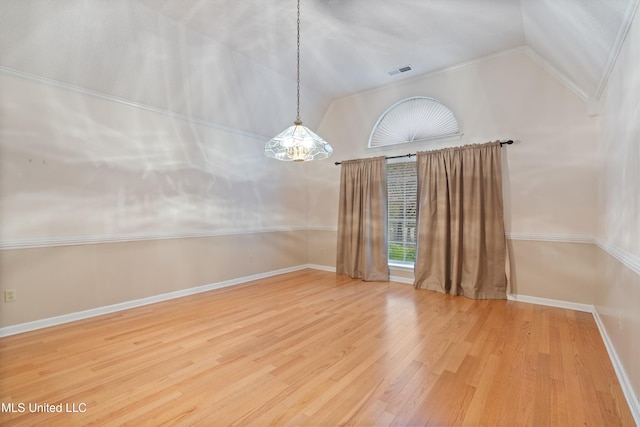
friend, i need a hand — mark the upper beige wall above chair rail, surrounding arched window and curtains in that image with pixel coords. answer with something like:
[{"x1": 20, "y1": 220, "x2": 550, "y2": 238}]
[{"x1": 307, "y1": 51, "x2": 599, "y2": 237}]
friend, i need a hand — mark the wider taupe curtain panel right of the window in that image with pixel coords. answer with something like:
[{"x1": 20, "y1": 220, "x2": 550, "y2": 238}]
[{"x1": 414, "y1": 142, "x2": 507, "y2": 299}]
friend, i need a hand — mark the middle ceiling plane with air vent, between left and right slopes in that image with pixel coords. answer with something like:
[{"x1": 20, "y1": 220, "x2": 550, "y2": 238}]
[{"x1": 141, "y1": 0, "x2": 525, "y2": 98}]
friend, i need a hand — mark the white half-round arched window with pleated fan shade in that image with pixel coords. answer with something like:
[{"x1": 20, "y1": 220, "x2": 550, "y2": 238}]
[{"x1": 369, "y1": 96, "x2": 460, "y2": 147}]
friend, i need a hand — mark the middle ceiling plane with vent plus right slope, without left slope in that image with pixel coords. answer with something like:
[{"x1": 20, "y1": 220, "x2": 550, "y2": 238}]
[{"x1": 140, "y1": 0, "x2": 633, "y2": 97}]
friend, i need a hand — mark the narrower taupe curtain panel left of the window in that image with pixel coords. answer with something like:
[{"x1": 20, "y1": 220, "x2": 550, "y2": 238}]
[{"x1": 336, "y1": 157, "x2": 389, "y2": 281}]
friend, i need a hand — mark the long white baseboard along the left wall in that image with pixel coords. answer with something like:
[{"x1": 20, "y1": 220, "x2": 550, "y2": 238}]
[{"x1": 0, "y1": 265, "x2": 310, "y2": 337}]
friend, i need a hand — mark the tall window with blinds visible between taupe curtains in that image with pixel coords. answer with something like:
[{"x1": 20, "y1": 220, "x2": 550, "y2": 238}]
[{"x1": 387, "y1": 162, "x2": 418, "y2": 267}]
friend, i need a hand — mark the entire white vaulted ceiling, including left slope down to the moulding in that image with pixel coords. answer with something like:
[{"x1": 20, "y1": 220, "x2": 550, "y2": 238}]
[{"x1": 0, "y1": 0, "x2": 639, "y2": 135}]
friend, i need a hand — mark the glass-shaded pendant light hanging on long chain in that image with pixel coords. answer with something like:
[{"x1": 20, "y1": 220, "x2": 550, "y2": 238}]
[{"x1": 264, "y1": 0, "x2": 333, "y2": 162}]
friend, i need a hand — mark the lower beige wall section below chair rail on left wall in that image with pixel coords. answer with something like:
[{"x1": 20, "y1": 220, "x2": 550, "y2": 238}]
[{"x1": 0, "y1": 230, "x2": 307, "y2": 328}]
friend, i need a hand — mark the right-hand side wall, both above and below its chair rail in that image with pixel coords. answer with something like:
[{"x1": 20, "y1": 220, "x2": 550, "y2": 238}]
[{"x1": 594, "y1": 3, "x2": 640, "y2": 414}]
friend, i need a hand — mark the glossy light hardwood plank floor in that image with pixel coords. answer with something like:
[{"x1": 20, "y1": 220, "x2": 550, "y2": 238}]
[{"x1": 0, "y1": 270, "x2": 634, "y2": 426}]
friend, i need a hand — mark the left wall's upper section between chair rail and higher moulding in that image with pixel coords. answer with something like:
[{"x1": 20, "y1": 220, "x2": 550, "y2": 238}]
[{"x1": 0, "y1": 75, "x2": 306, "y2": 243}]
